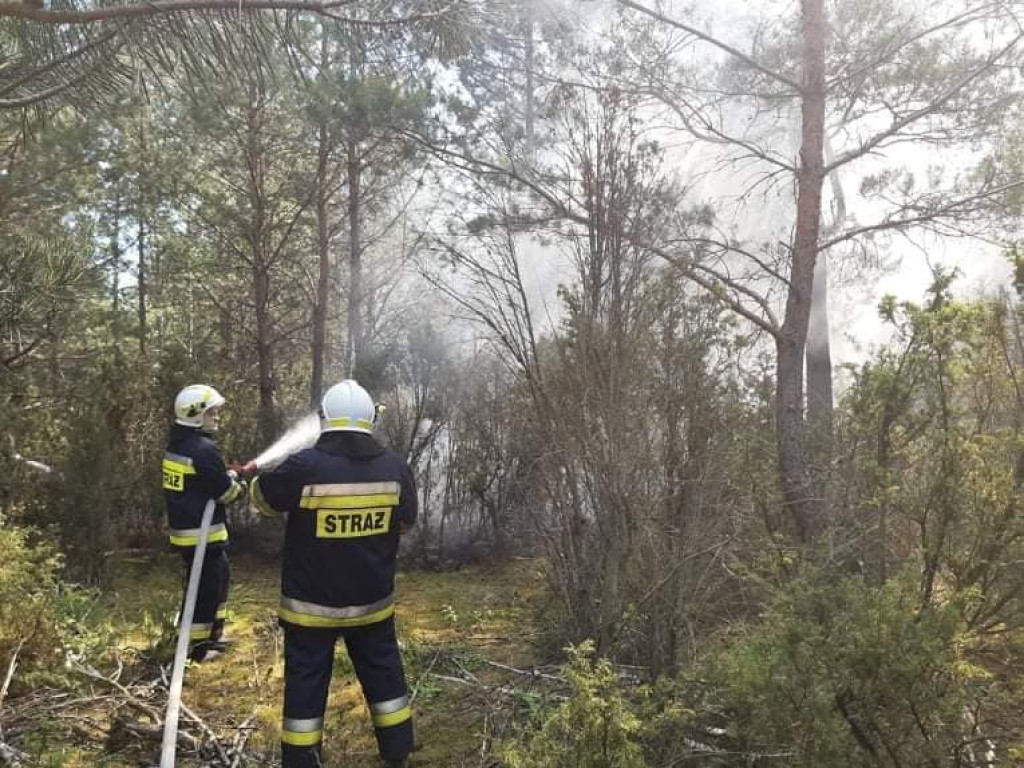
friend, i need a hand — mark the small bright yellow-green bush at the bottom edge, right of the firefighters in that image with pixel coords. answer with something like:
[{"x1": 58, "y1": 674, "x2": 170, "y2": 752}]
[{"x1": 502, "y1": 641, "x2": 645, "y2": 768}]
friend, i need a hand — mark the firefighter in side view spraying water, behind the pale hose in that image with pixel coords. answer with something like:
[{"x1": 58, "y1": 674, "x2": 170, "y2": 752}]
[{"x1": 163, "y1": 384, "x2": 243, "y2": 662}]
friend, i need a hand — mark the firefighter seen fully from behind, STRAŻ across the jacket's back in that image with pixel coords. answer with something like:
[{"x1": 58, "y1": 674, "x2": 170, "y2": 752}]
[{"x1": 252, "y1": 380, "x2": 418, "y2": 768}]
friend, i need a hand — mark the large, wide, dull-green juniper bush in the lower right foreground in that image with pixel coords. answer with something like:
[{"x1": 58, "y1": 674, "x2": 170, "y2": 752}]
[{"x1": 680, "y1": 573, "x2": 998, "y2": 768}]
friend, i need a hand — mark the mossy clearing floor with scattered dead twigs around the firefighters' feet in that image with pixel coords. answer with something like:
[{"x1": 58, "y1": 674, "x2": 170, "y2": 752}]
[{"x1": 8, "y1": 554, "x2": 560, "y2": 768}]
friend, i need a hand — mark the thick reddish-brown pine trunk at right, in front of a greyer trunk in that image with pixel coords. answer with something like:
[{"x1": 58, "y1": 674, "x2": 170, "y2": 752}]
[{"x1": 775, "y1": 0, "x2": 825, "y2": 543}]
